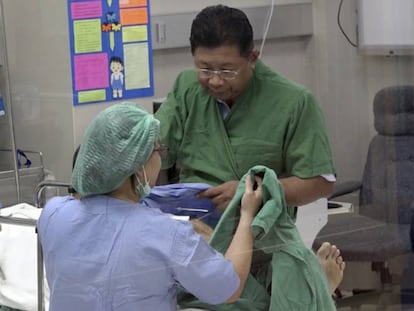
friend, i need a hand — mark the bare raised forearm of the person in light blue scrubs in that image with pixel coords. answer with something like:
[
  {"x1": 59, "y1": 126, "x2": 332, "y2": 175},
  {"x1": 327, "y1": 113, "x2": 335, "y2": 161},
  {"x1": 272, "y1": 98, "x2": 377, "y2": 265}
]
[{"x1": 224, "y1": 214, "x2": 253, "y2": 303}]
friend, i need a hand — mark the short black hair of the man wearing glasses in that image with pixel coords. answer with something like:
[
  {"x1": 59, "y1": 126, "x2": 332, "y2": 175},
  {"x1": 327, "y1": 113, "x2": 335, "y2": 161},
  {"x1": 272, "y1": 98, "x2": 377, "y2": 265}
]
[{"x1": 190, "y1": 5, "x2": 253, "y2": 57}]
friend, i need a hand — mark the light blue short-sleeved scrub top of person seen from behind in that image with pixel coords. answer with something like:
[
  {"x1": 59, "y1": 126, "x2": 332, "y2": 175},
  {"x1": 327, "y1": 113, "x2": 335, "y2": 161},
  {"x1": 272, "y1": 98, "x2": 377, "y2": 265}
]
[{"x1": 38, "y1": 195, "x2": 239, "y2": 311}]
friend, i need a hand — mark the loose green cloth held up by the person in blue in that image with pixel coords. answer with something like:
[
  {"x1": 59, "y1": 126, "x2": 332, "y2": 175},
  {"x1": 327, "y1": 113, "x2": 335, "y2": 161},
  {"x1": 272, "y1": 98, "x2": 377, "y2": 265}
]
[{"x1": 179, "y1": 166, "x2": 336, "y2": 311}]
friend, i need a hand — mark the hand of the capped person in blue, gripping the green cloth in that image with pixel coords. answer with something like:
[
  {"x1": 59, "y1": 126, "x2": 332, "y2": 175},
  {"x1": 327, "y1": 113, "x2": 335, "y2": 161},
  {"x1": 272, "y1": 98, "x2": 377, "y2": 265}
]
[{"x1": 240, "y1": 176, "x2": 262, "y2": 219}]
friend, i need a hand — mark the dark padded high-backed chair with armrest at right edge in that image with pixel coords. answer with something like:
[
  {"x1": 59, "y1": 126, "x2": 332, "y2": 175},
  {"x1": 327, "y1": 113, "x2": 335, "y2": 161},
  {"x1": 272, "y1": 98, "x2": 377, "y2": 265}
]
[{"x1": 313, "y1": 85, "x2": 414, "y2": 292}]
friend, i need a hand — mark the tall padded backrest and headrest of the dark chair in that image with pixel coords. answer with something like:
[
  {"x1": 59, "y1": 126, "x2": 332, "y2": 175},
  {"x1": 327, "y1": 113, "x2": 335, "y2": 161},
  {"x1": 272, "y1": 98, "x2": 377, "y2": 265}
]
[{"x1": 359, "y1": 85, "x2": 414, "y2": 224}]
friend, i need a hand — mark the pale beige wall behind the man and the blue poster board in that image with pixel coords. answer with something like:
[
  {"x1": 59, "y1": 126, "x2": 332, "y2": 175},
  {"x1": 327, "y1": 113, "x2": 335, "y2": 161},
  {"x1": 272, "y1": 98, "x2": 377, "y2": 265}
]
[{"x1": 3, "y1": 0, "x2": 414, "y2": 185}]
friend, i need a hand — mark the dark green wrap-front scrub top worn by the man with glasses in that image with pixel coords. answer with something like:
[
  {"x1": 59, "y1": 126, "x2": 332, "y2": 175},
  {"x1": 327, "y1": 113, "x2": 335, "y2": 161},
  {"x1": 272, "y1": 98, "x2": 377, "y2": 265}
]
[{"x1": 155, "y1": 61, "x2": 334, "y2": 186}]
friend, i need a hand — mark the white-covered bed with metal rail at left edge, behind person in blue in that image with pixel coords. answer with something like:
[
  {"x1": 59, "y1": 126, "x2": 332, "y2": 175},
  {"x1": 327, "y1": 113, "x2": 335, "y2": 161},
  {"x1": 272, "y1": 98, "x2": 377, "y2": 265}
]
[{"x1": 0, "y1": 181, "x2": 71, "y2": 311}]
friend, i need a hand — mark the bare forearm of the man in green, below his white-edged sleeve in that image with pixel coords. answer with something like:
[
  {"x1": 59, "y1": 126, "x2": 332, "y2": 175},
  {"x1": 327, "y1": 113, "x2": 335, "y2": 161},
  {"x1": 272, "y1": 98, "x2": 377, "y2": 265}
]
[{"x1": 280, "y1": 176, "x2": 334, "y2": 206}]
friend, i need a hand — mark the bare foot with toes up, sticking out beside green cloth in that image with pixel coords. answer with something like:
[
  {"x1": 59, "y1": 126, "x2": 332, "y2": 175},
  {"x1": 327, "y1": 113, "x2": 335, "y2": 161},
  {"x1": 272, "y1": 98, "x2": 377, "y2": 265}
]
[{"x1": 316, "y1": 242, "x2": 345, "y2": 294}]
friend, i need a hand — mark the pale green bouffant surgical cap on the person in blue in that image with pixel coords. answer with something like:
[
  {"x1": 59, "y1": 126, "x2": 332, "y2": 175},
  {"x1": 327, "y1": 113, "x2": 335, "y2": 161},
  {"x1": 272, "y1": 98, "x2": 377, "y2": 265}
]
[{"x1": 72, "y1": 102, "x2": 160, "y2": 196}]
